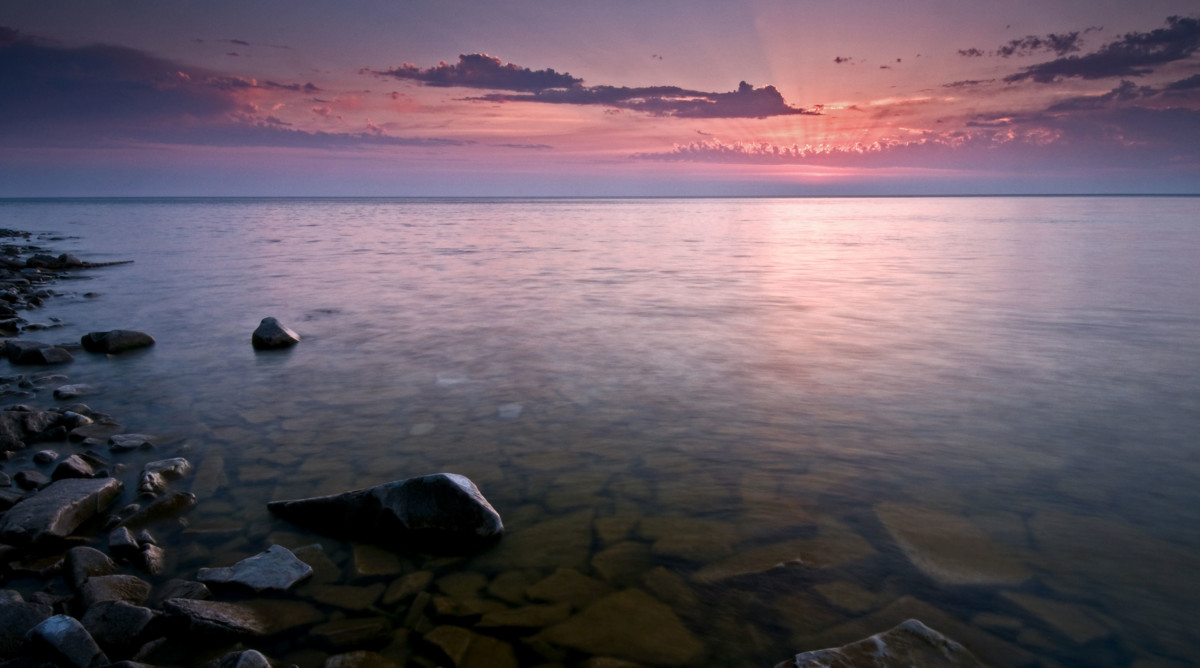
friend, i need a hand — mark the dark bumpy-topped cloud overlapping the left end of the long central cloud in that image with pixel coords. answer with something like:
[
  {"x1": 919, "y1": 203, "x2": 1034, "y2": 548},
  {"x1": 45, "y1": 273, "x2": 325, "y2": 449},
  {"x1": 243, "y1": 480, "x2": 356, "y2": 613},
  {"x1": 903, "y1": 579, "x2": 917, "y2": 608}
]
[{"x1": 370, "y1": 53, "x2": 583, "y2": 92}]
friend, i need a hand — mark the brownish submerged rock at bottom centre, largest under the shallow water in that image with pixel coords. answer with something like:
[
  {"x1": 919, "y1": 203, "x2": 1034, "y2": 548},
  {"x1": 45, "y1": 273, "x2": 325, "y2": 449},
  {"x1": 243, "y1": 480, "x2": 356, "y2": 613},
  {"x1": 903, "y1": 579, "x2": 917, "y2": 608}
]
[{"x1": 534, "y1": 589, "x2": 704, "y2": 666}]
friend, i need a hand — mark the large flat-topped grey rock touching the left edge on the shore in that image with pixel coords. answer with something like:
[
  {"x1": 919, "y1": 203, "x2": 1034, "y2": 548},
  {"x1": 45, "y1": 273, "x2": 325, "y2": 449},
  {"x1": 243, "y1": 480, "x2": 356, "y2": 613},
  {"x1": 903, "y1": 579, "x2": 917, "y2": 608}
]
[{"x1": 0, "y1": 477, "x2": 122, "y2": 546}]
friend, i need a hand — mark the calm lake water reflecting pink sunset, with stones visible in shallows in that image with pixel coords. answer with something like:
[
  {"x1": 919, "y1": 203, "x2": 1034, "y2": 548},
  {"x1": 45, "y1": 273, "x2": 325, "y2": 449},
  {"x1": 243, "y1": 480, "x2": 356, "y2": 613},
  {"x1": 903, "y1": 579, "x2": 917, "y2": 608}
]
[{"x1": 0, "y1": 198, "x2": 1200, "y2": 668}]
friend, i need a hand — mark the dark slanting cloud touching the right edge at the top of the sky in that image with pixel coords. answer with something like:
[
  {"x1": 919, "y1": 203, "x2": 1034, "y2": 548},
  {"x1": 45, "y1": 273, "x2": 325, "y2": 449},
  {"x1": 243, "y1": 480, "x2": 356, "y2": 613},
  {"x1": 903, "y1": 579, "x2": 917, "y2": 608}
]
[{"x1": 1004, "y1": 17, "x2": 1200, "y2": 84}]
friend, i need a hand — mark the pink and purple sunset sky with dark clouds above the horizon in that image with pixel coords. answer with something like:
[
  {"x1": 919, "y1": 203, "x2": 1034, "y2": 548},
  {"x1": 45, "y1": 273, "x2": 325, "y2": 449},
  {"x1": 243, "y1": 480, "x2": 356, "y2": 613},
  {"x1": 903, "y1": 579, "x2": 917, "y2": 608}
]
[{"x1": 0, "y1": 0, "x2": 1200, "y2": 197}]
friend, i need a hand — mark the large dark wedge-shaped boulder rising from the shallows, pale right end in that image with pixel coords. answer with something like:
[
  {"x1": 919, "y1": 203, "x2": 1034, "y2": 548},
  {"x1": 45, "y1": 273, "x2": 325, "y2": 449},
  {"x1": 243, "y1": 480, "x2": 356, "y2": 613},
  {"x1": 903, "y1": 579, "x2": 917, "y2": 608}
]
[{"x1": 268, "y1": 474, "x2": 504, "y2": 552}]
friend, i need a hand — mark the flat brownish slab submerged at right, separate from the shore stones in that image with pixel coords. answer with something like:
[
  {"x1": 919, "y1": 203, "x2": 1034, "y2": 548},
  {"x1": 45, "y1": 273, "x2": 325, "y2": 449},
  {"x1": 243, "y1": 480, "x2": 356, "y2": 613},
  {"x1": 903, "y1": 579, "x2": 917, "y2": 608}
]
[{"x1": 875, "y1": 504, "x2": 1032, "y2": 585}]
